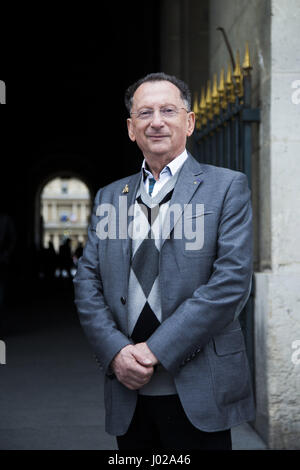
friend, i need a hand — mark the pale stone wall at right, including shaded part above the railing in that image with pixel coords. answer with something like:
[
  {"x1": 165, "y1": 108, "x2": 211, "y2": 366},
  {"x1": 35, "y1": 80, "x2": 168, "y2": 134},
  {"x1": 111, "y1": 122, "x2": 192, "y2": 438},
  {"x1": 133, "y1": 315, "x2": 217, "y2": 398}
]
[{"x1": 210, "y1": 0, "x2": 300, "y2": 449}]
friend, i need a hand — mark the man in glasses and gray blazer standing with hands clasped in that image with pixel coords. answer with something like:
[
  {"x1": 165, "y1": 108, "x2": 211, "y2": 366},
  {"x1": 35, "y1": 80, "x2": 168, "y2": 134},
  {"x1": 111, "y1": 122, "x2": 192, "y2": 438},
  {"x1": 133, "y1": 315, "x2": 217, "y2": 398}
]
[{"x1": 74, "y1": 73, "x2": 254, "y2": 449}]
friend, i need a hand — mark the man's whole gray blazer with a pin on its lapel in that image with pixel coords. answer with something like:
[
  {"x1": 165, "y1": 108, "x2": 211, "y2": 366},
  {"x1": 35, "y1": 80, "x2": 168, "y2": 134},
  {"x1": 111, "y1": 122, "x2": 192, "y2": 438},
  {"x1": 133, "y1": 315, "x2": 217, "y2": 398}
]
[{"x1": 74, "y1": 155, "x2": 254, "y2": 435}]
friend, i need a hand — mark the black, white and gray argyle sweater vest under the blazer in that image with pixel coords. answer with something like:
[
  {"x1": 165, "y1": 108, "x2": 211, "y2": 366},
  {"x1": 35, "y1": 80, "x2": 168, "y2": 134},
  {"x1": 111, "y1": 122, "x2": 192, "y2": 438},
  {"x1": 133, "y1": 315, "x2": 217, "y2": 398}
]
[{"x1": 128, "y1": 172, "x2": 179, "y2": 395}]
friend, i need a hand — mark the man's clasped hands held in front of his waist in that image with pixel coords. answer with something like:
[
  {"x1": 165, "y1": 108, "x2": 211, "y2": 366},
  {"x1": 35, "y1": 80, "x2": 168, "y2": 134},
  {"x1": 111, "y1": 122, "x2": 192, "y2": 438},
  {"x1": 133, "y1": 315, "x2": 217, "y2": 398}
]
[{"x1": 111, "y1": 343, "x2": 158, "y2": 390}]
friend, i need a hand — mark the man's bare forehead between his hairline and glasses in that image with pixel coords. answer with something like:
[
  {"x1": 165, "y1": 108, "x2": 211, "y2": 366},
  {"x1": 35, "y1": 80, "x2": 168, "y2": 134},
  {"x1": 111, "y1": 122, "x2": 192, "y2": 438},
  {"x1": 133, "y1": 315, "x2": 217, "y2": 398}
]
[{"x1": 133, "y1": 80, "x2": 183, "y2": 108}]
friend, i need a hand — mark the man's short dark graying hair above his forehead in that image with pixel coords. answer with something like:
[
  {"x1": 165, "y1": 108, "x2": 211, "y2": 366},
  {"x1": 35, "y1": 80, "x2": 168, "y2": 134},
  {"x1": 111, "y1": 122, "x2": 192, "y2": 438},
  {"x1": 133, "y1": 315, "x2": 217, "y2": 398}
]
[{"x1": 125, "y1": 72, "x2": 192, "y2": 114}]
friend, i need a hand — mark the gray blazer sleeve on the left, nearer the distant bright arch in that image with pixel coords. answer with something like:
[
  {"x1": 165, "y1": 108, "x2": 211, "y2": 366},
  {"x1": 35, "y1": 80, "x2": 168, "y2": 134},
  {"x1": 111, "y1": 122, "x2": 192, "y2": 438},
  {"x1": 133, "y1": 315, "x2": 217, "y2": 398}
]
[{"x1": 73, "y1": 190, "x2": 131, "y2": 374}]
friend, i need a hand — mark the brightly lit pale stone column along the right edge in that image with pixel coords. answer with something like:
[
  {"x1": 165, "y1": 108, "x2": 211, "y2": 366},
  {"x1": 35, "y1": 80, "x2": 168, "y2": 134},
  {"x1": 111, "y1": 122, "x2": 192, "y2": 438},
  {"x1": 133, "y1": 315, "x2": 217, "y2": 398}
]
[{"x1": 255, "y1": 0, "x2": 300, "y2": 449}]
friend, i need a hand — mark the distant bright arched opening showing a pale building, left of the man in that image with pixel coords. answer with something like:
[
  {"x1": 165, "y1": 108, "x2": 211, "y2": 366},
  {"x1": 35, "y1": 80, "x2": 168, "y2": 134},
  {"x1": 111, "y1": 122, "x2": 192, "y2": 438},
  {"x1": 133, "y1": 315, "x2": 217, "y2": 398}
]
[{"x1": 34, "y1": 172, "x2": 92, "y2": 278}]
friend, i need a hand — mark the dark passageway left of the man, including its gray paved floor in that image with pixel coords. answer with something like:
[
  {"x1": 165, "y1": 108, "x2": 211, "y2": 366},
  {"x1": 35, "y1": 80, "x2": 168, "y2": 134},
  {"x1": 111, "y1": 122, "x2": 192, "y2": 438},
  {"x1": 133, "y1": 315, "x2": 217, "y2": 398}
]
[{"x1": 0, "y1": 1, "x2": 160, "y2": 449}]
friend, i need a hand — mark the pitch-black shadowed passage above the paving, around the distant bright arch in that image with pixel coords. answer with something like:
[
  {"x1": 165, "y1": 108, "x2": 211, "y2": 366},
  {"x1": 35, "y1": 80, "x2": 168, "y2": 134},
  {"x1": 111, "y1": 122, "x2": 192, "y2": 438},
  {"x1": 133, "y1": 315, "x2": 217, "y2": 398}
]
[{"x1": 0, "y1": 1, "x2": 160, "y2": 312}]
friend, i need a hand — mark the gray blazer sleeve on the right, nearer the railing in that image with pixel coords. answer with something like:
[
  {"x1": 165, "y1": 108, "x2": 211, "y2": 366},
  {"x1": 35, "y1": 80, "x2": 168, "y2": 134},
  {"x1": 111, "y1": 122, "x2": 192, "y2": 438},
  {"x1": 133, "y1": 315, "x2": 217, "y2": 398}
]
[{"x1": 147, "y1": 172, "x2": 252, "y2": 374}]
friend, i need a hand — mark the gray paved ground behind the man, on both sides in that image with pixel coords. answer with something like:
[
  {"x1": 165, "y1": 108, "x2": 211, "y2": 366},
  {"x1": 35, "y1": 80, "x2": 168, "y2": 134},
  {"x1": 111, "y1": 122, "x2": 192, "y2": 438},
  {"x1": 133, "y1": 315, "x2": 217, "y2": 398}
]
[{"x1": 0, "y1": 285, "x2": 266, "y2": 450}]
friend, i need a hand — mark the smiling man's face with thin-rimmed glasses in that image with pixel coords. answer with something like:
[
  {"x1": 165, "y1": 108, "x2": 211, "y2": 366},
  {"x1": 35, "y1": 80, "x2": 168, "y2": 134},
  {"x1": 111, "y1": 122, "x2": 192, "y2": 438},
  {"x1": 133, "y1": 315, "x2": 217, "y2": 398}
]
[{"x1": 127, "y1": 81, "x2": 195, "y2": 160}]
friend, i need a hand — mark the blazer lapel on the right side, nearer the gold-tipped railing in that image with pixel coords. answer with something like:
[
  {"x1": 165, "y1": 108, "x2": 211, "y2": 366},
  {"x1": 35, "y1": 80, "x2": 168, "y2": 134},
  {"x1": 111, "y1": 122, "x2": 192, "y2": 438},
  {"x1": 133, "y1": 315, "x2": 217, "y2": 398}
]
[{"x1": 162, "y1": 154, "x2": 203, "y2": 245}]
